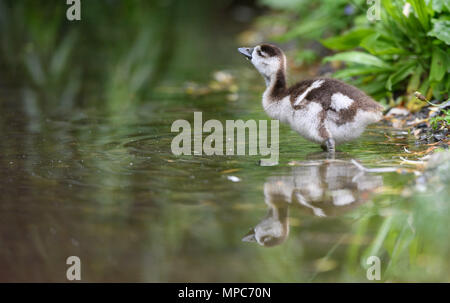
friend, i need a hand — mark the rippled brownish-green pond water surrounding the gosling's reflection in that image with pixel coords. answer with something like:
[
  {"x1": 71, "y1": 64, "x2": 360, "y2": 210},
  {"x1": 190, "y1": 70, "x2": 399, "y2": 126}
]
[{"x1": 0, "y1": 83, "x2": 448, "y2": 282}]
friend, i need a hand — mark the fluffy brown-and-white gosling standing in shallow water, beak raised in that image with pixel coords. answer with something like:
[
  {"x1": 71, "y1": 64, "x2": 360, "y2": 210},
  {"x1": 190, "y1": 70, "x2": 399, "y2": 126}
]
[{"x1": 238, "y1": 44, "x2": 383, "y2": 153}]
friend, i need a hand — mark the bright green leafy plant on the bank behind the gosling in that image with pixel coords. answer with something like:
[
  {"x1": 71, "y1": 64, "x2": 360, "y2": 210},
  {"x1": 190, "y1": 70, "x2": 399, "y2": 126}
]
[{"x1": 322, "y1": 0, "x2": 450, "y2": 100}]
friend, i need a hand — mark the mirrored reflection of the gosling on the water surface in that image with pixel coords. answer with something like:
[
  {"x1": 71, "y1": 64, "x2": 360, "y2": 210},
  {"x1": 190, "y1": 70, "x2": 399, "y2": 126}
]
[{"x1": 242, "y1": 161, "x2": 383, "y2": 247}]
